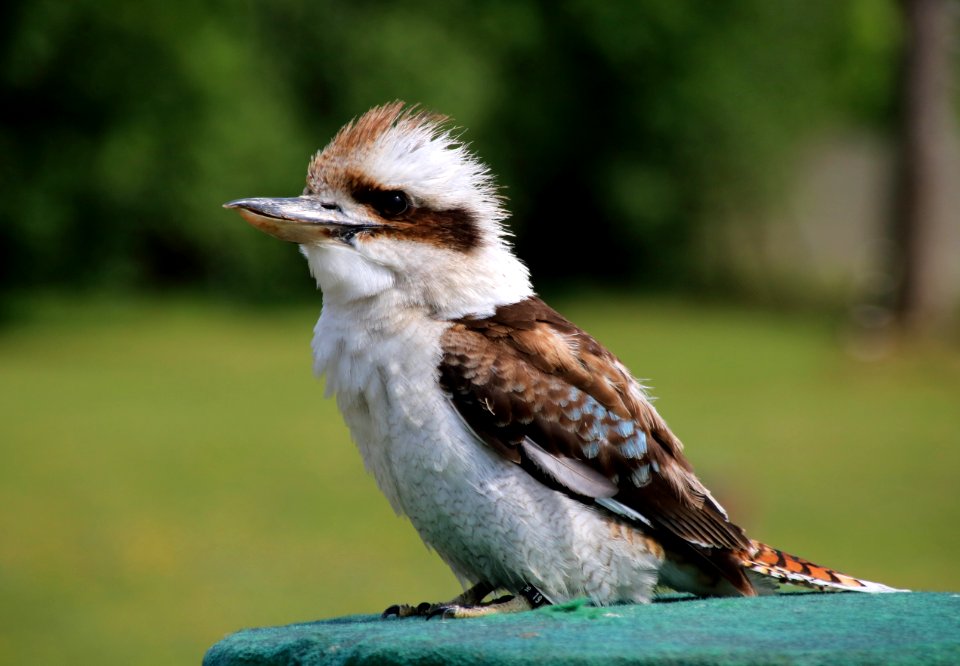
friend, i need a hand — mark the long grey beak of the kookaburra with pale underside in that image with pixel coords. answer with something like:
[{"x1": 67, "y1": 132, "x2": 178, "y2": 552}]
[{"x1": 223, "y1": 196, "x2": 374, "y2": 243}]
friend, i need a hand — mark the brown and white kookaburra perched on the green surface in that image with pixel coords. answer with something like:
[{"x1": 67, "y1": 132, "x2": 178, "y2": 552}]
[{"x1": 224, "y1": 101, "x2": 898, "y2": 618}]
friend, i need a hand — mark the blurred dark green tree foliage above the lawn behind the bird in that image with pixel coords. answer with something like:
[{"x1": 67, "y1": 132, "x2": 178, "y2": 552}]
[{"x1": 0, "y1": 0, "x2": 898, "y2": 297}]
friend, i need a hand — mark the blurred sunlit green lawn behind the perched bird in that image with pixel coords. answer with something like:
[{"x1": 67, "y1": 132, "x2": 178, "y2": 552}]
[{"x1": 0, "y1": 298, "x2": 960, "y2": 664}]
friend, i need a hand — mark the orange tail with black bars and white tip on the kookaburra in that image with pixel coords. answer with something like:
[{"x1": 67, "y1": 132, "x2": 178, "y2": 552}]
[{"x1": 741, "y1": 541, "x2": 908, "y2": 592}]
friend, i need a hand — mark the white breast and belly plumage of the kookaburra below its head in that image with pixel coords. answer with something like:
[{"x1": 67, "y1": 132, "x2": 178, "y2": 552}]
[{"x1": 313, "y1": 290, "x2": 659, "y2": 602}]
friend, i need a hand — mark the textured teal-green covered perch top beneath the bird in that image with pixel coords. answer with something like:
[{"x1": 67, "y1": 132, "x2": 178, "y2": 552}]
[{"x1": 203, "y1": 592, "x2": 960, "y2": 666}]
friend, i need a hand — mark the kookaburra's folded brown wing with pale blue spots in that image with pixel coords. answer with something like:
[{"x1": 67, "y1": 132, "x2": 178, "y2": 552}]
[{"x1": 440, "y1": 298, "x2": 751, "y2": 556}]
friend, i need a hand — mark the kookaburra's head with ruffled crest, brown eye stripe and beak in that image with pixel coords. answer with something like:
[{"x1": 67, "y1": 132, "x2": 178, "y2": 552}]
[{"x1": 225, "y1": 102, "x2": 532, "y2": 318}]
